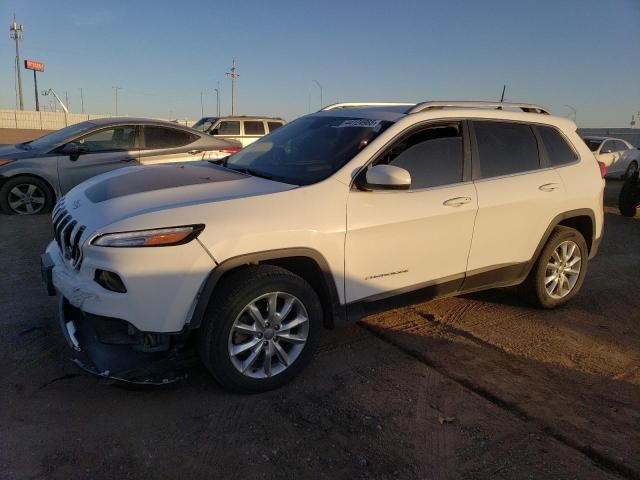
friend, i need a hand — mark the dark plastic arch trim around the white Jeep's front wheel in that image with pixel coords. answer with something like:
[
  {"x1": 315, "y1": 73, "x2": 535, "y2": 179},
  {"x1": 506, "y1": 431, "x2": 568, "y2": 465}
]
[{"x1": 189, "y1": 247, "x2": 346, "y2": 329}]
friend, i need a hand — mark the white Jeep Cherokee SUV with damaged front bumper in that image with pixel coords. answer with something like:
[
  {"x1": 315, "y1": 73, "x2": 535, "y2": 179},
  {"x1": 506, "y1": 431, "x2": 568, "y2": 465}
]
[{"x1": 42, "y1": 102, "x2": 604, "y2": 391}]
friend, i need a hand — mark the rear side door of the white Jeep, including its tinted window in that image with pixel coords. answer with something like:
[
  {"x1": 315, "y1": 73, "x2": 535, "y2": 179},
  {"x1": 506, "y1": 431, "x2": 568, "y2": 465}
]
[{"x1": 463, "y1": 120, "x2": 565, "y2": 289}]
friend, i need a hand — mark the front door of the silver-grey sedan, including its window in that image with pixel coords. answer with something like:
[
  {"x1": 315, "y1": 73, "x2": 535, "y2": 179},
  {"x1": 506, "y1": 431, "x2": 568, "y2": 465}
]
[{"x1": 56, "y1": 125, "x2": 139, "y2": 194}]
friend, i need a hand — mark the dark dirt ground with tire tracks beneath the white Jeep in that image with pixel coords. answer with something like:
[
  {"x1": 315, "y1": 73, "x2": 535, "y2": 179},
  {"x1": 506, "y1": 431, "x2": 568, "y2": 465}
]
[{"x1": 0, "y1": 182, "x2": 640, "y2": 480}]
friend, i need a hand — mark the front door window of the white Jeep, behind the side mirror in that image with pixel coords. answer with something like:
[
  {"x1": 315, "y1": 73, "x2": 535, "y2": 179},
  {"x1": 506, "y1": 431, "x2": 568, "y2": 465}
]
[{"x1": 375, "y1": 122, "x2": 464, "y2": 190}]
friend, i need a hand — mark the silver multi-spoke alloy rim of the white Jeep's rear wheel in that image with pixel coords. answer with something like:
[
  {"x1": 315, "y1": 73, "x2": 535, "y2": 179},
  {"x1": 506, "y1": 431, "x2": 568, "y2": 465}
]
[{"x1": 544, "y1": 240, "x2": 582, "y2": 299}]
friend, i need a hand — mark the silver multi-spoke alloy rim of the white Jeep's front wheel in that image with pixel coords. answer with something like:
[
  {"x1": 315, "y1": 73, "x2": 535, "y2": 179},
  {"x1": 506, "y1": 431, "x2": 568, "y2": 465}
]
[{"x1": 228, "y1": 292, "x2": 309, "y2": 378}]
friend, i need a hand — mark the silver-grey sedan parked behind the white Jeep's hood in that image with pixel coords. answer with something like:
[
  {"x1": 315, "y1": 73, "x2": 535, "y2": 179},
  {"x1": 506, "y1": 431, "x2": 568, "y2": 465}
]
[{"x1": 0, "y1": 118, "x2": 241, "y2": 215}]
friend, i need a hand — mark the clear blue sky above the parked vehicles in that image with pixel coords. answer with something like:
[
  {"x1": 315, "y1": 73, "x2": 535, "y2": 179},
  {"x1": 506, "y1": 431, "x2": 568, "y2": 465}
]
[{"x1": 0, "y1": 0, "x2": 640, "y2": 127}]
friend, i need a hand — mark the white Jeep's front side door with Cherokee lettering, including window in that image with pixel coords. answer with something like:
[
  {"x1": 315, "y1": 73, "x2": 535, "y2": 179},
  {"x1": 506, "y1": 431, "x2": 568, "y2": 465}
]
[{"x1": 345, "y1": 121, "x2": 478, "y2": 302}]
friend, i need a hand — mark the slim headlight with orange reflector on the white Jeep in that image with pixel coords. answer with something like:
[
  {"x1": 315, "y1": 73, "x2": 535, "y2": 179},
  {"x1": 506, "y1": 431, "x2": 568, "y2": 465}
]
[{"x1": 91, "y1": 225, "x2": 204, "y2": 247}]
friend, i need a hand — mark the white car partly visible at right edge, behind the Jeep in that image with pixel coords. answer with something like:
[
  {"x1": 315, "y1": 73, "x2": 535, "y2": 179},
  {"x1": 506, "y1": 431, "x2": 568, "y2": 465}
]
[{"x1": 584, "y1": 137, "x2": 640, "y2": 178}]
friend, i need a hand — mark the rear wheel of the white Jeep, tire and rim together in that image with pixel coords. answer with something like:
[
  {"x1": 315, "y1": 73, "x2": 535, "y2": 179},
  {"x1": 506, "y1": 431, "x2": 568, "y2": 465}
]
[{"x1": 521, "y1": 226, "x2": 589, "y2": 309}]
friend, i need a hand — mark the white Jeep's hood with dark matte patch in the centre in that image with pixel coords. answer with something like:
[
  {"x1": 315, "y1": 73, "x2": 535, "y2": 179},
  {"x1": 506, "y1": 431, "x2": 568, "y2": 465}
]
[{"x1": 58, "y1": 162, "x2": 295, "y2": 231}]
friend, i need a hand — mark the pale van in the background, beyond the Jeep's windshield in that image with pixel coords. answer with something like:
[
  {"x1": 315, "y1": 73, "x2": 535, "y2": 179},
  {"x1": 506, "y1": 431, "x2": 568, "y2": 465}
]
[{"x1": 191, "y1": 115, "x2": 285, "y2": 147}]
